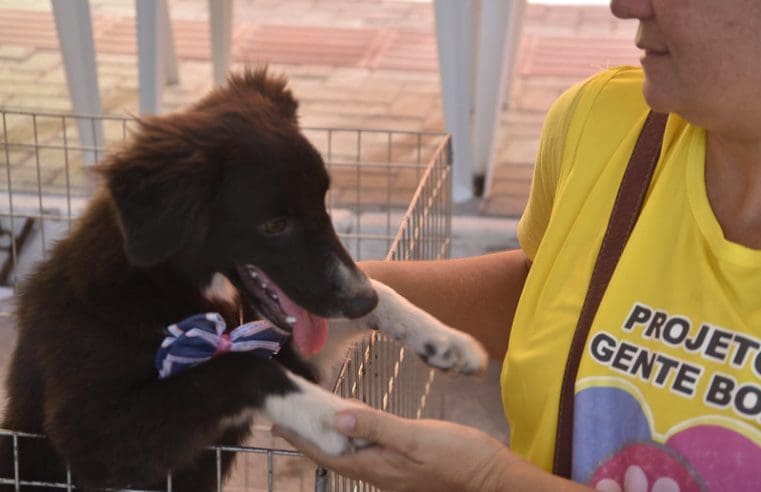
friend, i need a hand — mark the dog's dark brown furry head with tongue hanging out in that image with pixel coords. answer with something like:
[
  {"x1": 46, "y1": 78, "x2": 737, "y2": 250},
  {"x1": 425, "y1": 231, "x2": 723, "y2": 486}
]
[{"x1": 101, "y1": 70, "x2": 377, "y2": 354}]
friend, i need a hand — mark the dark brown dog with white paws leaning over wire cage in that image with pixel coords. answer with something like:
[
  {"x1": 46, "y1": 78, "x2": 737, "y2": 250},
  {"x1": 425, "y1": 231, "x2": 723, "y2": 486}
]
[{"x1": 0, "y1": 70, "x2": 486, "y2": 492}]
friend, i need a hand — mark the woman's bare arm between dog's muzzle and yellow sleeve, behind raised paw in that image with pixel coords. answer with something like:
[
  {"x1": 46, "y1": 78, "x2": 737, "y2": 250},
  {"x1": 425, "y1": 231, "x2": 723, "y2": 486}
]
[{"x1": 359, "y1": 249, "x2": 530, "y2": 360}]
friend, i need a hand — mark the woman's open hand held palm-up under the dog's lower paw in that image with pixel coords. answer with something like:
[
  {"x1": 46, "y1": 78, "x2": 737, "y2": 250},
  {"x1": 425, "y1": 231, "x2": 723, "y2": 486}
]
[{"x1": 275, "y1": 408, "x2": 510, "y2": 492}]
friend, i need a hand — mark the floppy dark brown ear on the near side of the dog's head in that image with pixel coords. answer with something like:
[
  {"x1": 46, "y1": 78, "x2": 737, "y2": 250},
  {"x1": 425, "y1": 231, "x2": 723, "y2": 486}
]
[{"x1": 98, "y1": 116, "x2": 218, "y2": 267}]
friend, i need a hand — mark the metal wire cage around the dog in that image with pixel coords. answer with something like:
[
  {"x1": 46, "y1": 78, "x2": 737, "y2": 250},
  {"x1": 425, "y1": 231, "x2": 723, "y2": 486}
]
[{"x1": 0, "y1": 108, "x2": 451, "y2": 492}]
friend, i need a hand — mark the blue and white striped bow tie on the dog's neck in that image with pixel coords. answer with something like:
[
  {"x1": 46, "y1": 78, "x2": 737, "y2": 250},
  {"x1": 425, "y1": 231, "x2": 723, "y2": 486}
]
[{"x1": 155, "y1": 313, "x2": 288, "y2": 378}]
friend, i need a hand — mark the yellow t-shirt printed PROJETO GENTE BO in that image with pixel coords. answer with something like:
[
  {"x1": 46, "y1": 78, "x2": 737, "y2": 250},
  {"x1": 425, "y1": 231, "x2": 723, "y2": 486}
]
[{"x1": 502, "y1": 68, "x2": 761, "y2": 491}]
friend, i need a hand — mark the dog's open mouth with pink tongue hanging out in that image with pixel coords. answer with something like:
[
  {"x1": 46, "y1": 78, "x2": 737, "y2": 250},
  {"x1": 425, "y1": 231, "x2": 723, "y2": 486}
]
[{"x1": 235, "y1": 263, "x2": 328, "y2": 356}]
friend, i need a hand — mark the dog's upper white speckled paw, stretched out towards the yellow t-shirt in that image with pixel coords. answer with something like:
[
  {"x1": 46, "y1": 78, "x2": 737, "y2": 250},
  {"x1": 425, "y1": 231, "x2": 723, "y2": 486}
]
[{"x1": 368, "y1": 280, "x2": 489, "y2": 374}]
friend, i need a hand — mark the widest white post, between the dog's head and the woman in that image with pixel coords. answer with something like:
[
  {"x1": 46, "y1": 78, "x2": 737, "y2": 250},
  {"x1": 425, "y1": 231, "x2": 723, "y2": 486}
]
[{"x1": 434, "y1": 0, "x2": 525, "y2": 202}]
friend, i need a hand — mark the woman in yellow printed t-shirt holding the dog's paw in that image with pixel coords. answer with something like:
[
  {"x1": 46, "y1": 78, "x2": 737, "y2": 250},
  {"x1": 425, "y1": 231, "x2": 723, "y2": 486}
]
[{"x1": 278, "y1": 0, "x2": 761, "y2": 492}]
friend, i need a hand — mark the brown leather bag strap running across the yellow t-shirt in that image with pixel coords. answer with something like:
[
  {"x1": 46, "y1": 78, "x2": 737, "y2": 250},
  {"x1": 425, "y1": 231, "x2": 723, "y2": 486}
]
[{"x1": 553, "y1": 111, "x2": 668, "y2": 478}]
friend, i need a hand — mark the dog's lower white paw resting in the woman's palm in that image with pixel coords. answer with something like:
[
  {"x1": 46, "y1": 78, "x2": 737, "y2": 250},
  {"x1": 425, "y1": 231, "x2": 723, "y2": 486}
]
[{"x1": 264, "y1": 373, "x2": 362, "y2": 455}]
